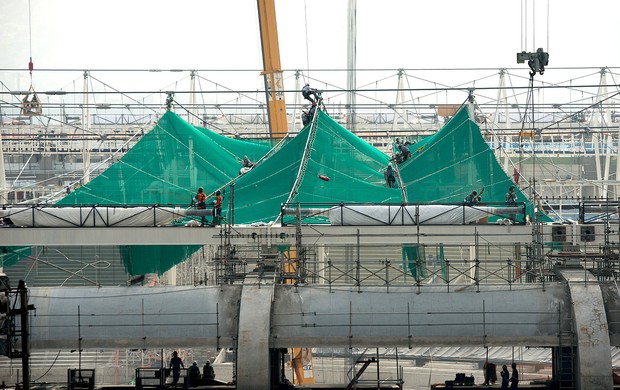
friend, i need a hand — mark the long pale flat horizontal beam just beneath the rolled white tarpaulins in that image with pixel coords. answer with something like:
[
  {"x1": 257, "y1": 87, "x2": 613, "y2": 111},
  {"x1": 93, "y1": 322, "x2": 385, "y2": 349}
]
[{"x1": 0, "y1": 225, "x2": 536, "y2": 246}]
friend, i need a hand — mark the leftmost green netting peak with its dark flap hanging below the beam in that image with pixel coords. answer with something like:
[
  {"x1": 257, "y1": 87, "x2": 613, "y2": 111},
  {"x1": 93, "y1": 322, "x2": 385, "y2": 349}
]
[{"x1": 58, "y1": 111, "x2": 271, "y2": 275}]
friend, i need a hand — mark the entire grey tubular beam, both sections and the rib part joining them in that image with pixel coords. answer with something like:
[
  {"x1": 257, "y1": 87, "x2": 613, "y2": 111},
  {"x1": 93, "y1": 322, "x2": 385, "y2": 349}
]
[{"x1": 30, "y1": 283, "x2": 574, "y2": 348}]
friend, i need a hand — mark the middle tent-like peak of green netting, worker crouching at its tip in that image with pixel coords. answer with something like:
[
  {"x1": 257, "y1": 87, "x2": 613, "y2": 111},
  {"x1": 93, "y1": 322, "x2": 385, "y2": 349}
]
[{"x1": 229, "y1": 111, "x2": 402, "y2": 223}]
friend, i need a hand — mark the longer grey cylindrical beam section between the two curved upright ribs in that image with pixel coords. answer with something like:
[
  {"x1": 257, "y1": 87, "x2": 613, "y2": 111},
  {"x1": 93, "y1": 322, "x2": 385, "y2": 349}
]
[{"x1": 271, "y1": 283, "x2": 572, "y2": 348}]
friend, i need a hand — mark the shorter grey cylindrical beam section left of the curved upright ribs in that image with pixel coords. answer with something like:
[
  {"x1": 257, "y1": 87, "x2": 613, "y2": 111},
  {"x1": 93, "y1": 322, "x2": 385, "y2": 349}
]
[{"x1": 29, "y1": 286, "x2": 242, "y2": 349}]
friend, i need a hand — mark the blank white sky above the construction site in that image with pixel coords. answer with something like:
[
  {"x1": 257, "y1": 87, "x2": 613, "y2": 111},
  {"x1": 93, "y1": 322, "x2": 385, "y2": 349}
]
[{"x1": 0, "y1": 0, "x2": 620, "y2": 103}]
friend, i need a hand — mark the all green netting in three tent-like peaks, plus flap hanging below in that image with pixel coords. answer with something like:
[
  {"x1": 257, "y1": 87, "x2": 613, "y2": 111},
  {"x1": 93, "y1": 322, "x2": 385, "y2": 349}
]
[{"x1": 3, "y1": 102, "x2": 544, "y2": 275}]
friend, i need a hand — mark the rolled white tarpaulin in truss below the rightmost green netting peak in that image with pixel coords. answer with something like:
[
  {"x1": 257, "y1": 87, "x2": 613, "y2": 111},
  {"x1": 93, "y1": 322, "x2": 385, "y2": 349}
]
[{"x1": 329, "y1": 205, "x2": 522, "y2": 225}]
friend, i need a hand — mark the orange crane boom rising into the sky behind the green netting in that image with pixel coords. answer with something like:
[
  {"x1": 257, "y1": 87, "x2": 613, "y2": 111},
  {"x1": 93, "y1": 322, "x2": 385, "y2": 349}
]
[{"x1": 257, "y1": 0, "x2": 288, "y2": 139}]
